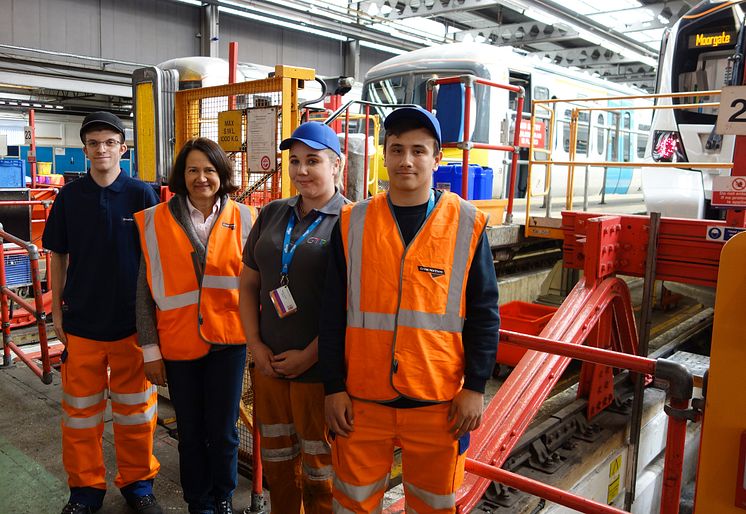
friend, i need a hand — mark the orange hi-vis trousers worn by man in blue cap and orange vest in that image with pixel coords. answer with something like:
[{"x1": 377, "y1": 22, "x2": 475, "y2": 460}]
[{"x1": 332, "y1": 399, "x2": 466, "y2": 514}]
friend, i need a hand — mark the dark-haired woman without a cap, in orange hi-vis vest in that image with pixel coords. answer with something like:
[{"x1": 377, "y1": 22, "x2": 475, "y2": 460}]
[{"x1": 135, "y1": 138, "x2": 256, "y2": 513}]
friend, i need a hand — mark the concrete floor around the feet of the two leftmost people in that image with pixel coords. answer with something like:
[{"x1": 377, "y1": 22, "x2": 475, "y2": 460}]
[{"x1": 0, "y1": 363, "x2": 251, "y2": 514}]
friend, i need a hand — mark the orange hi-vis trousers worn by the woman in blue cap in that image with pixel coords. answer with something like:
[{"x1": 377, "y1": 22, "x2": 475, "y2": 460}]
[{"x1": 252, "y1": 369, "x2": 332, "y2": 514}]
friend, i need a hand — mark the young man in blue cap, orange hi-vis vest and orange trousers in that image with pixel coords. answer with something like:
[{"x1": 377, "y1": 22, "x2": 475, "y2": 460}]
[{"x1": 319, "y1": 107, "x2": 499, "y2": 514}]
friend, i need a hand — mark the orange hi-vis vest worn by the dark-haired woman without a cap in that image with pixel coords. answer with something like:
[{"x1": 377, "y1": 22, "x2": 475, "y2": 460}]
[{"x1": 135, "y1": 200, "x2": 256, "y2": 360}]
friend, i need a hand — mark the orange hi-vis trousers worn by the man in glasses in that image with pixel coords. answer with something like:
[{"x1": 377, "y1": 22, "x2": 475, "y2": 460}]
[{"x1": 62, "y1": 334, "x2": 160, "y2": 489}]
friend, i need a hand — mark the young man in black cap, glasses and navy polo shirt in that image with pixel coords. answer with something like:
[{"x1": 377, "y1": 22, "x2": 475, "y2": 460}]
[{"x1": 42, "y1": 111, "x2": 162, "y2": 514}]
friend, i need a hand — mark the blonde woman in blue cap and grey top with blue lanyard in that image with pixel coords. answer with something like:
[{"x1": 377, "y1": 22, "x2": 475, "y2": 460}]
[{"x1": 240, "y1": 122, "x2": 347, "y2": 514}]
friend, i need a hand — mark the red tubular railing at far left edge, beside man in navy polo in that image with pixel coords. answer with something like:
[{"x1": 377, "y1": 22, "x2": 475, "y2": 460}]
[{"x1": 0, "y1": 223, "x2": 52, "y2": 384}]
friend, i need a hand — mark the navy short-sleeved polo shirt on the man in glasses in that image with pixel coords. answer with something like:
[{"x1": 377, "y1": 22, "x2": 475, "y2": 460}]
[{"x1": 42, "y1": 171, "x2": 158, "y2": 341}]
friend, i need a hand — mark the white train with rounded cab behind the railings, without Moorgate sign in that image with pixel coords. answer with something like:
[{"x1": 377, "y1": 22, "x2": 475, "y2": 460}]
[{"x1": 363, "y1": 43, "x2": 651, "y2": 204}]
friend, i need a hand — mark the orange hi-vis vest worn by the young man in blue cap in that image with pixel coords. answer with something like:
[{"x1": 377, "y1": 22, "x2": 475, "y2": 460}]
[{"x1": 340, "y1": 192, "x2": 487, "y2": 402}]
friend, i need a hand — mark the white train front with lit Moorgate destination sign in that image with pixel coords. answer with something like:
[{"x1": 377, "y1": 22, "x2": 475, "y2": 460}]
[{"x1": 641, "y1": 0, "x2": 746, "y2": 219}]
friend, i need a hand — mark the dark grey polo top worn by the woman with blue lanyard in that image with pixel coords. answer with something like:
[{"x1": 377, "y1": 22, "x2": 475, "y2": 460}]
[{"x1": 243, "y1": 191, "x2": 348, "y2": 382}]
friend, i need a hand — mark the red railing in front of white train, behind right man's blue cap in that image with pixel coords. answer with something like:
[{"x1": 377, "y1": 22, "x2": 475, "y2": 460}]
[{"x1": 426, "y1": 75, "x2": 525, "y2": 223}]
